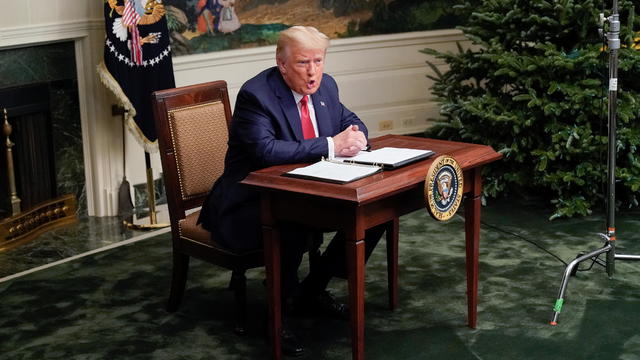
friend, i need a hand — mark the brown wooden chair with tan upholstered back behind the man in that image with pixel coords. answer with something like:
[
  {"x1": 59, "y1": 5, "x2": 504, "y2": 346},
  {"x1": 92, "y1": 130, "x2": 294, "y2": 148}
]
[{"x1": 152, "y1": 81, "x2": 264, "y2": 334}]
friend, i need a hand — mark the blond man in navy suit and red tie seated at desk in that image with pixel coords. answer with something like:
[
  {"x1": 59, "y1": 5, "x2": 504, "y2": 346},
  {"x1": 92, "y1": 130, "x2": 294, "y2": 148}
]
[{"x1": 199, "y1": 26, "x2": 384, "y2": 355}]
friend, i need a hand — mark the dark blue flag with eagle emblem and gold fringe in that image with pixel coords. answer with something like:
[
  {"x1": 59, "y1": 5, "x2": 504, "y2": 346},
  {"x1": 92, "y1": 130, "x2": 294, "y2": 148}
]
[{"x1": 98, "y1": 0, "x2": 175, "y2": 148}]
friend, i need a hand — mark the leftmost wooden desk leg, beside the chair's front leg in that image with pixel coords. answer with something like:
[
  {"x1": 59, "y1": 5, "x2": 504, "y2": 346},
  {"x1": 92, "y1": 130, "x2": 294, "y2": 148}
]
[{"x1": 262, "y1": 226, "x2": 282, "y2": 360}]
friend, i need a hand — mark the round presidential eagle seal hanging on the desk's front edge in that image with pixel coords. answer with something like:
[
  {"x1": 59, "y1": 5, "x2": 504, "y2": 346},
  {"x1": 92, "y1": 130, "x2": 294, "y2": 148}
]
[{"x1": 424, "y1": 155, "x2": 464, "y2": 221}]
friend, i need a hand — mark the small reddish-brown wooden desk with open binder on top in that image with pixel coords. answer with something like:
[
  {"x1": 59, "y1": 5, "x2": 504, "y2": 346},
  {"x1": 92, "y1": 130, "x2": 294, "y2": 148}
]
[{"x1": 242, "y1": 135, "x2": 501, "y2": 360}]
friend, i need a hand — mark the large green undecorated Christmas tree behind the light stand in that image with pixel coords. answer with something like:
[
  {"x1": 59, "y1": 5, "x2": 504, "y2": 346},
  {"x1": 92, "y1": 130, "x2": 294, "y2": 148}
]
[{"x1": 423, "y1": 0, "x2": 640, "y2": 218}]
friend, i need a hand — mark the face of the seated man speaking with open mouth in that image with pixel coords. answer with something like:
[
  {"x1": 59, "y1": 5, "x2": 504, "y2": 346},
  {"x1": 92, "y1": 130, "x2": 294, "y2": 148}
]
[{"x1": 278, "y1": 45, "x2": 325, "y2": 95}]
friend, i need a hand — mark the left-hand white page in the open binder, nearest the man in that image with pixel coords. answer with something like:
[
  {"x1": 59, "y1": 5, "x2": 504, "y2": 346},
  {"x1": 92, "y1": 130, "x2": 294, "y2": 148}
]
[{"x1": 287, "y1": 160, "x2": 381, "y2": 183}]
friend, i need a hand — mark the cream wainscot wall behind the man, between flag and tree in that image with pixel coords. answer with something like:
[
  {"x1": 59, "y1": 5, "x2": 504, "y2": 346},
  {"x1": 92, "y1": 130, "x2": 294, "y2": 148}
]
[{"x1": 174, "y1": 30, "x2": 464, "y2": 136}]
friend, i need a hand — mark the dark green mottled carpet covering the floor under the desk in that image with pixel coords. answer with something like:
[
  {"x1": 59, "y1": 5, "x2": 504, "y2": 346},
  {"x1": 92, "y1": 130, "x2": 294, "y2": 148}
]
[{"x1": 0, "y1": 199, "x2": 640, "y2": 360}]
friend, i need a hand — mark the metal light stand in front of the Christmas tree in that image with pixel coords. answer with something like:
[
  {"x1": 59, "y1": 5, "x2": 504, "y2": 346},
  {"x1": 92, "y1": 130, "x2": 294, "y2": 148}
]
[{"x1": 550, "y1": 0, "x2": 640, "y2": 325}]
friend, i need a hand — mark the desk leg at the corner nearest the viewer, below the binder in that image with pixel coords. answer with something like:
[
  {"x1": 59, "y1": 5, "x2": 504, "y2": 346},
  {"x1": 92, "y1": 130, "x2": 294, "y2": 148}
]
[{"x1": 346, "y1": 240, "x2": 364, "y2": 360}]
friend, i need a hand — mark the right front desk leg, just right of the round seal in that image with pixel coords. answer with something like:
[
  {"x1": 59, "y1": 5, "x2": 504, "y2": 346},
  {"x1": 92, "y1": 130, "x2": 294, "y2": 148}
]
[{"x1": 464, "y1": 168, "x2": 482, "y2": 329}]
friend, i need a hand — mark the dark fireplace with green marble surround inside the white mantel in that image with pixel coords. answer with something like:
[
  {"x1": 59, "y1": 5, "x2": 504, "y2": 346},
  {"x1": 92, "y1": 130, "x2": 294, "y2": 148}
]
[{"x1": 0, "y1": 42, "x2": 86, "y2": 218}]
